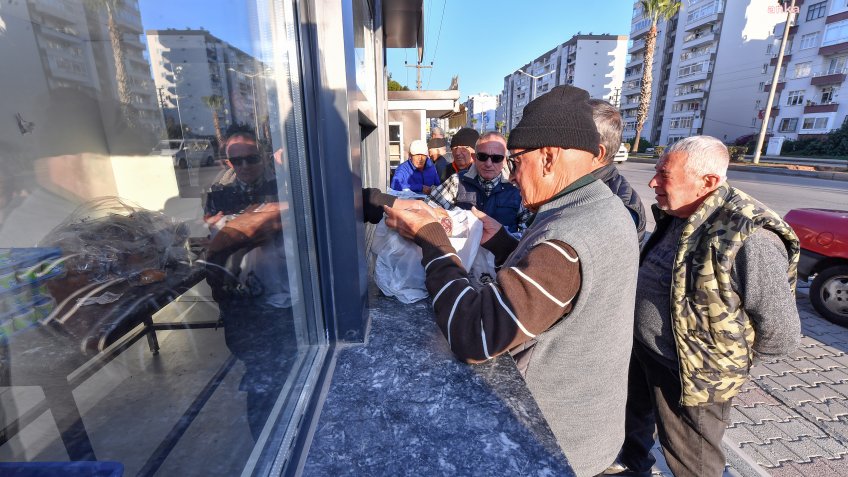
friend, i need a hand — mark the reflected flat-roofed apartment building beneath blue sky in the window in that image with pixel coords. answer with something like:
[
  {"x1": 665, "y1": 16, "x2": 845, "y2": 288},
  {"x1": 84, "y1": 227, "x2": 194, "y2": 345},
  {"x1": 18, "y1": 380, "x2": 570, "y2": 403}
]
[{"x1": 147, "y1": 29, "x2": 270, "y2": 137}]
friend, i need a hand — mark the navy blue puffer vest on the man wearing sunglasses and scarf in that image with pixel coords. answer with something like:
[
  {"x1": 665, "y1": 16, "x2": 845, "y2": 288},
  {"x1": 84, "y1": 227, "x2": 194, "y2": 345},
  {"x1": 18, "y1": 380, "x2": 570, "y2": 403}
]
[{"x1": 456, "y1": 170, "x2": 521, "y2": 233}]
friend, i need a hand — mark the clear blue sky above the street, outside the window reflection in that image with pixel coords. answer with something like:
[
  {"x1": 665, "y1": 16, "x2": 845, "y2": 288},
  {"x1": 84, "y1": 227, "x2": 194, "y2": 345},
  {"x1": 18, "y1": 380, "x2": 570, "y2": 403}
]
[{"x1": 387, "y1": 0, "x2": 633, "y2": 100}]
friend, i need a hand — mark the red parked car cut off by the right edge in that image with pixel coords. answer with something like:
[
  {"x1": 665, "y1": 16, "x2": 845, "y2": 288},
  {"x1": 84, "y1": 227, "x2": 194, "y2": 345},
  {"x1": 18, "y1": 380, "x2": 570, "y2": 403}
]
[{"x1": 786, "y1": 209, "x2": 848, "y2": 326}]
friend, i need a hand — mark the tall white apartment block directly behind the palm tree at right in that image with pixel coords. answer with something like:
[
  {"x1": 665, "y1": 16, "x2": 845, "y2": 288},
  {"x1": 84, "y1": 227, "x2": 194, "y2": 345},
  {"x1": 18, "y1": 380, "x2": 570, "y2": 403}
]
[{"x1": 620, "y1": 0, "x2": 782, "y2": 145}]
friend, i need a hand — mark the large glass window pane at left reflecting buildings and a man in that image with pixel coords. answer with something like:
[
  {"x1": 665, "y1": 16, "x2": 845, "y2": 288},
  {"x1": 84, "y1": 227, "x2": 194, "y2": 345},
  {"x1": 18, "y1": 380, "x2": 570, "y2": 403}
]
[{"x1": 0, "y1": 0, "x2": 332, "y2": 476}]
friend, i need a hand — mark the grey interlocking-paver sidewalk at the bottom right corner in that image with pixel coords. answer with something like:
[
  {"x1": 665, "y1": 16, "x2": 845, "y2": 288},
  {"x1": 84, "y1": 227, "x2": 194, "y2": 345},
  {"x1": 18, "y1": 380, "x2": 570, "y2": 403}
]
[{"x1": 653, "y1": 288, "x2": 848, "y2": 477}]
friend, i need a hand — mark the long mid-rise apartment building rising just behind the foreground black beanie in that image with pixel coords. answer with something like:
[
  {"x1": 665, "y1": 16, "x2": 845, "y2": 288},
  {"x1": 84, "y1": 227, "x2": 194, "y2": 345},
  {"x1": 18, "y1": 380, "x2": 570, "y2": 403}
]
[{"x1": 496, "y1": 33, "x2": 627, "y2": 131}]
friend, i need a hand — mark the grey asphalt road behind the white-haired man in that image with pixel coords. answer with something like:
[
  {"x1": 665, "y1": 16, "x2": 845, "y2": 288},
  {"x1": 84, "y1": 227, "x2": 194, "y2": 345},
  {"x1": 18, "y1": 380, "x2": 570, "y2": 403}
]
[{"x1": 618, "y1": 162, "x2": 848, "y2": 230}]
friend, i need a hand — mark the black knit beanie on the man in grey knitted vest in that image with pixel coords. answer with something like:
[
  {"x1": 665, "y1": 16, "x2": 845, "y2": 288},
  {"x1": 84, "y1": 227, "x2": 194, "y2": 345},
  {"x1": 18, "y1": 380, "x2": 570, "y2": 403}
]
[{"x1": 507, "y1": 85, "x2": 601, "y2": 156}]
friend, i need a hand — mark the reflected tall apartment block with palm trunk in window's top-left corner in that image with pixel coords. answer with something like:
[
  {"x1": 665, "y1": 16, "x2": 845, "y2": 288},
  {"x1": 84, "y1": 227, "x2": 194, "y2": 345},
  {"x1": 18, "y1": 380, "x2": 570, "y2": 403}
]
[{"x1": 0, "y1": 0, "x2": 162, "y2": 155}]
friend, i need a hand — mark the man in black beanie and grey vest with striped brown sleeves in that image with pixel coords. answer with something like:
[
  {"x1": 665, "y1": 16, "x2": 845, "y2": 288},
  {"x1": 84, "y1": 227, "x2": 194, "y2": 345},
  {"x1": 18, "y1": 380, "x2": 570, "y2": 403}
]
[{"x1": 384, "y1": 86, "x2": 639, "y2": 476}]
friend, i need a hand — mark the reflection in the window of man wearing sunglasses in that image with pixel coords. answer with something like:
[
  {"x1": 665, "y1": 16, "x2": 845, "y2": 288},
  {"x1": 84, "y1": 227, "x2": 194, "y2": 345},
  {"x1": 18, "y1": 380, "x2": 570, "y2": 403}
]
[{"x1": 204, "y1": 133, "x2": 294, "y2": 438}]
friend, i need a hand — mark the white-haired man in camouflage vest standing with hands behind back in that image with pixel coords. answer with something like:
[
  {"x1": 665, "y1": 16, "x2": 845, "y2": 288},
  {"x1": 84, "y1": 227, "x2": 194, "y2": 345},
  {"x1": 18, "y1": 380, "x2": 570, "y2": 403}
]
[{"x1": 607, "y1": 136, "x2": 800, "y2": 477}]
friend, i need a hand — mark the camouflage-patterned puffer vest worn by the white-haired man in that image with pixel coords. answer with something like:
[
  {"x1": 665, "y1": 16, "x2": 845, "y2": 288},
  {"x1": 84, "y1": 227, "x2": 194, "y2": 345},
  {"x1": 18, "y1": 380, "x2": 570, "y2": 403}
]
[{"x1": 646, "y1": 183, "x2": 800, "y2": 406}]
